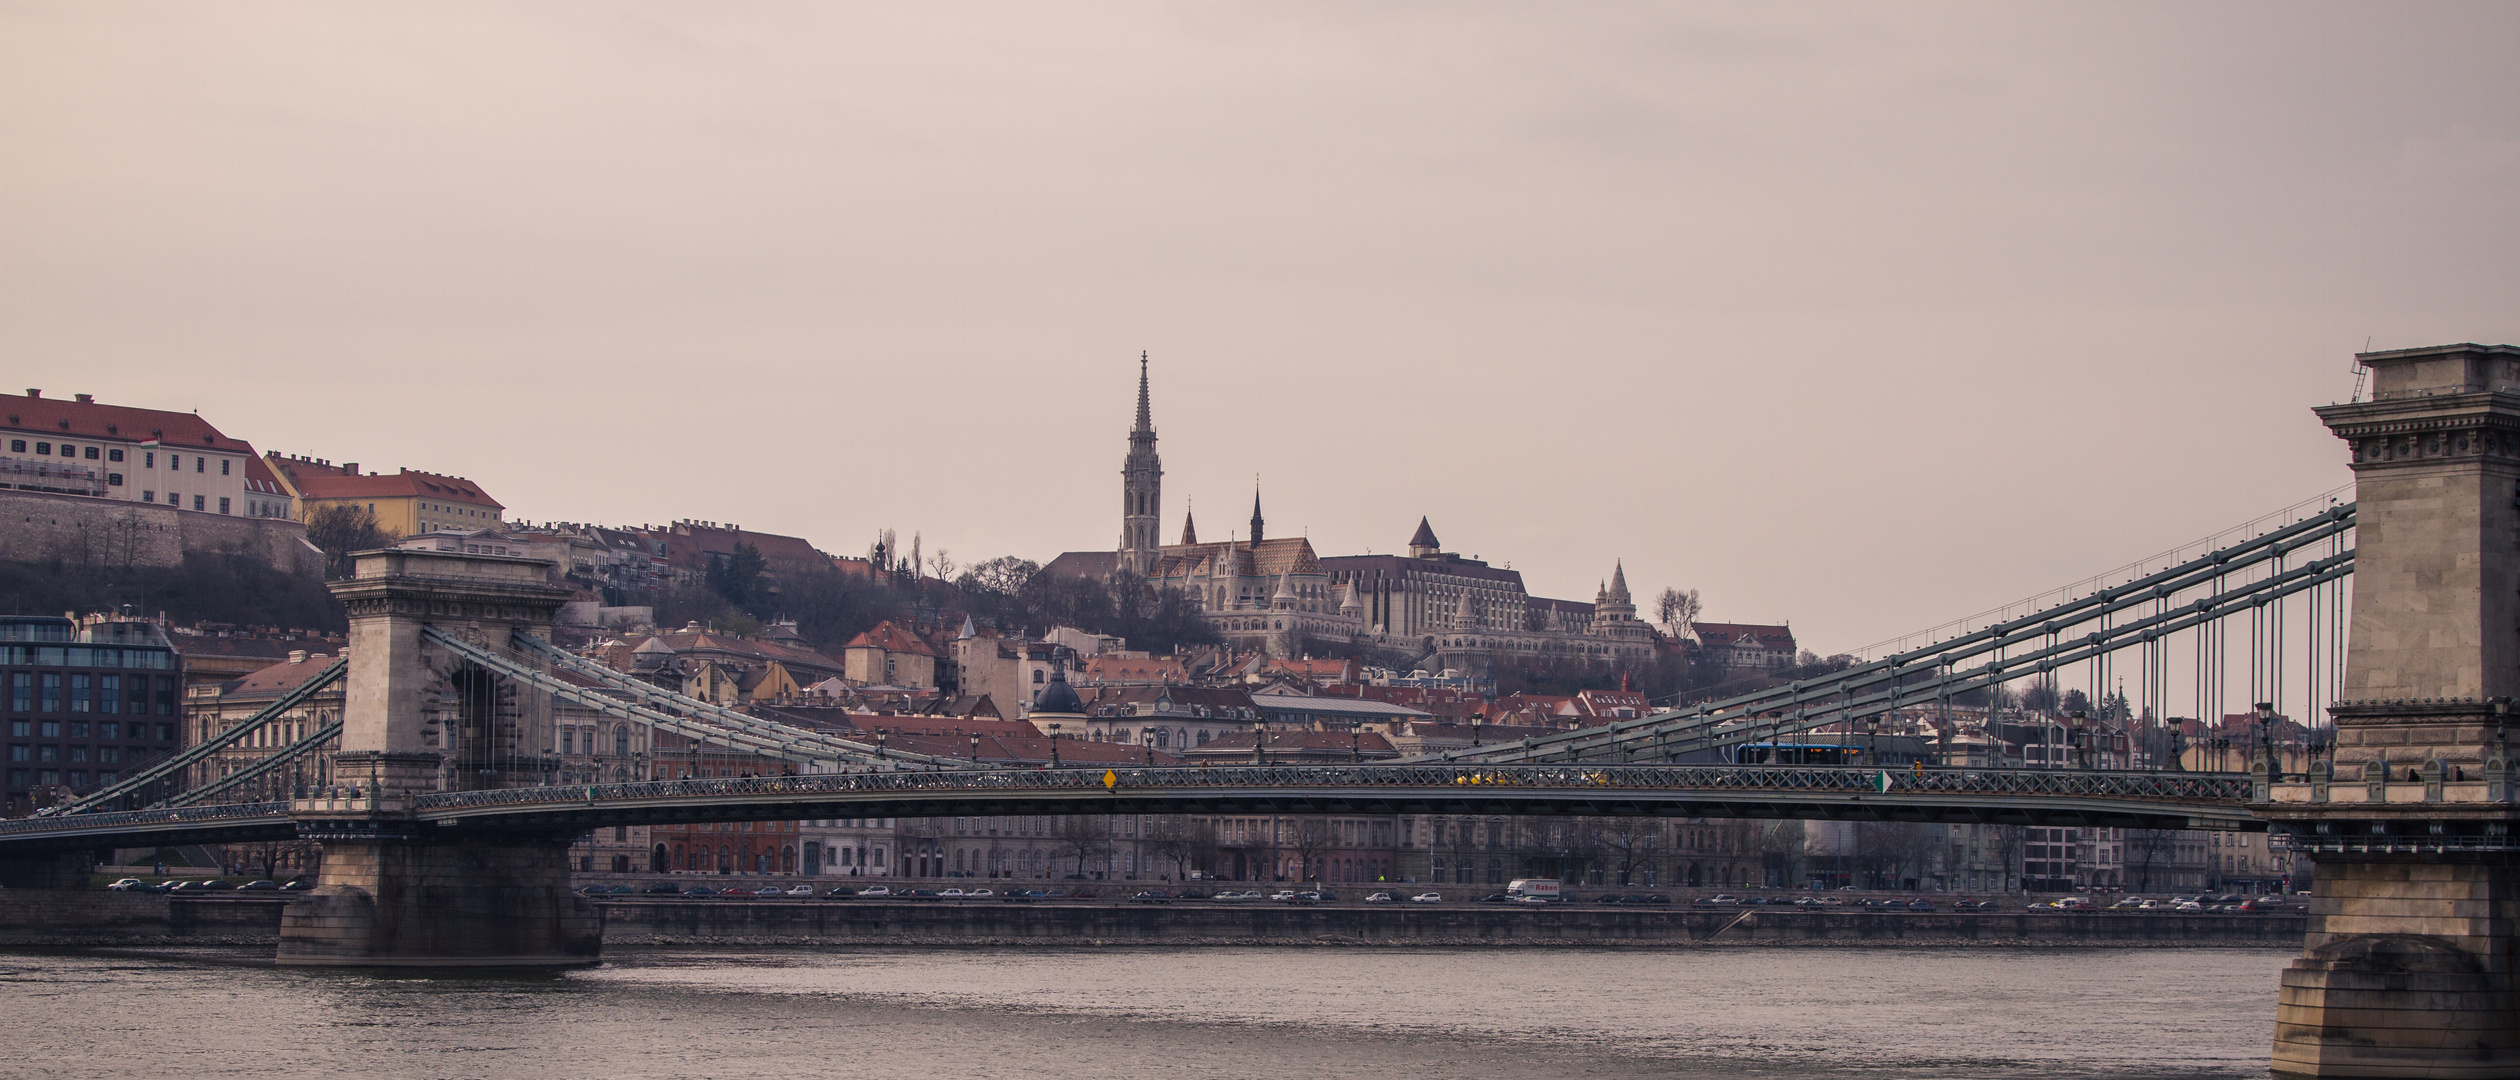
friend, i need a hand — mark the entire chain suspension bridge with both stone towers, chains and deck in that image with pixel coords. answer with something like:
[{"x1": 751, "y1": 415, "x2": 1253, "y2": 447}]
[{"x1": 0, "y1": 345, "x2": 2520, "y2": 1077}]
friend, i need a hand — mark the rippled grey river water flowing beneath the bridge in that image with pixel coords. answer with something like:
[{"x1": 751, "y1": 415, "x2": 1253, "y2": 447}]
[{"x1": 0, "y1": 947, "x2": 2293, "y2": 1080}]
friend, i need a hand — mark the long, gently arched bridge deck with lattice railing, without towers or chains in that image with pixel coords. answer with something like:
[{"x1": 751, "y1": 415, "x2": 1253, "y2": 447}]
[{"x1": 0, "y1": 765, "x2": 2263, "y2": 851}]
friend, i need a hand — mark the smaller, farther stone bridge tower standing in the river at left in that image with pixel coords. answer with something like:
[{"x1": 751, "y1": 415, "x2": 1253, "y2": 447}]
[{"x1": 280, "y1": 551, "x2": 602, "y2": 967}]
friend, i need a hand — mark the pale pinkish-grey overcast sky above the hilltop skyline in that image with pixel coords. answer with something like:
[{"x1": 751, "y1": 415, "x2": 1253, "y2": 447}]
[{"x1": 0, "y1": 0, "x2": 2520, "y2": 652}]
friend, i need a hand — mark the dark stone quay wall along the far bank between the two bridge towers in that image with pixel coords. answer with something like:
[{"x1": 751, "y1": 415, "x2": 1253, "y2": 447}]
[{"x1": 597, "y1": 899, "x2": 2306, "y2": 949}]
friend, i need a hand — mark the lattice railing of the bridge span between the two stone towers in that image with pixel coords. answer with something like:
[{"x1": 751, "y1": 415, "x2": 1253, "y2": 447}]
[{"x1": 418, "y1": 765, "x2": 2250, "y2": 813}]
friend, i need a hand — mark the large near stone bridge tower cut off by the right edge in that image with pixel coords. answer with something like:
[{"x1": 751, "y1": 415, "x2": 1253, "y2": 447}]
[{"x1": 2258, "y1": 345, "x2": 2520, "y2": 1077}]
